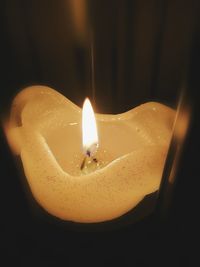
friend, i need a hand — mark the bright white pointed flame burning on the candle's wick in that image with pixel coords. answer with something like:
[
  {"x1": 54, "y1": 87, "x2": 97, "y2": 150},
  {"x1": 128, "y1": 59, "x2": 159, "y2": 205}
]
[{"x1": 82, "y1": 98, "x2": 98, "y2": 156}]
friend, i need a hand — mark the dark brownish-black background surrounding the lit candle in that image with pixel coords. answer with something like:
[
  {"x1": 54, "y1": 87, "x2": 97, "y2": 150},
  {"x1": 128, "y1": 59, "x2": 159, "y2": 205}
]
[{"x1": 0, "y1": 0, "x2": 200, "y2": 266}]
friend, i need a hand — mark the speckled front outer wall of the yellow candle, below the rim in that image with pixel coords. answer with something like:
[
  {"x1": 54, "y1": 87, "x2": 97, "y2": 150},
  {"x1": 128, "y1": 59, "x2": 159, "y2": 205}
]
[{"x1": 21, "y1": 133, "x2": 165, "y2": 222}]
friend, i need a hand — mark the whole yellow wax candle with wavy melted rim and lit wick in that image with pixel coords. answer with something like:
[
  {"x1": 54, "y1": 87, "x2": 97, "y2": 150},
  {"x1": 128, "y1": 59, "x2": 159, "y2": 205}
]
[{"x1": 5, "y1": 86, "x2": 174, "y2": 223}]
